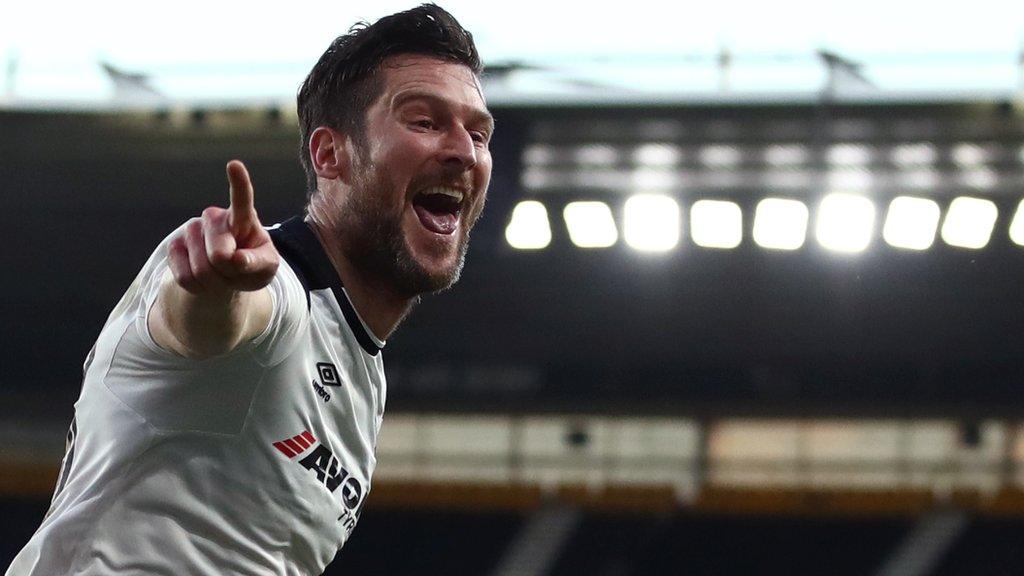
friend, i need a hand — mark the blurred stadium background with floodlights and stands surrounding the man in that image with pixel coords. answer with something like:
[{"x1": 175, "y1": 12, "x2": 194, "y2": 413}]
[{"x1": 0, "y1": 0, "x2": 1024, "y2": 576}]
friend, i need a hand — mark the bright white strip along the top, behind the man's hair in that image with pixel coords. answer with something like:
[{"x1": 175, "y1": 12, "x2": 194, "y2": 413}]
[{"x1": 0, "y1": 0, "x2": 1024, "y2": 109}]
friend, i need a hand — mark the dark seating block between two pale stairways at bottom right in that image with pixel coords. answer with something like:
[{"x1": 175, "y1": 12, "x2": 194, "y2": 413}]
[{"x1": 552, "y1": 515, "x2": 911, "y2": 576}]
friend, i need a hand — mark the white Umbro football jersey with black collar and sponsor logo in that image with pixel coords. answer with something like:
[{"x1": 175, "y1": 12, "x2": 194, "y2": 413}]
[{"x1": 7, "y1": 218, "x2": 386, "y2": 576}]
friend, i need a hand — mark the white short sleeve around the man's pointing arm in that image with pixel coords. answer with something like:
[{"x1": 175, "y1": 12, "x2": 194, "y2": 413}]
[{"x1": 103, "y1": 226, "x2": 309, "y2": 435}]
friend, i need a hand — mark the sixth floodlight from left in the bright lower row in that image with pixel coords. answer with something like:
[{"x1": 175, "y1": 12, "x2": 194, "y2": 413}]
[{"x1": 814, "y1": 193, "x2": 874, "y2": 252}]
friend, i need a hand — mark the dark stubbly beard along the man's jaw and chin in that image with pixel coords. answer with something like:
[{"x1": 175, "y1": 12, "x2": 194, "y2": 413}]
[{"x1": 339, "y1": 162, "x2": 478, "y2": 298}]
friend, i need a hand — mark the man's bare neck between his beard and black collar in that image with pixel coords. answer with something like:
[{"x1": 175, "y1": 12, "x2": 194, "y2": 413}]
[{"x1": 306, "y1": 215, "x2": 417, "y2": 340}]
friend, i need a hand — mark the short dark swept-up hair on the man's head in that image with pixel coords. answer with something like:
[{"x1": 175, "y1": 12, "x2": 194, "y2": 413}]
[{"x1": 297, "y1": 4, "x2": 483, "y2": 194}]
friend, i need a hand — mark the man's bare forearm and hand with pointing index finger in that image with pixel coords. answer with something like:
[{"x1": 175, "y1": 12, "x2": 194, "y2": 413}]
[{"x1": 148, "y1": 160, "x2": 280, "y2": 359}]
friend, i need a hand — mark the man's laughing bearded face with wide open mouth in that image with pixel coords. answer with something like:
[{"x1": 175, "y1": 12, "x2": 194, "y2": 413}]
[{"x1": 337, "y1": 55, "x2": 494, "y2": 296}]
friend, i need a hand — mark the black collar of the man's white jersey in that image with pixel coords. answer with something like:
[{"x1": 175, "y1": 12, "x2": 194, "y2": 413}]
[{"x1": 268, "y1": 216, "x2": 381, "y2": 356}]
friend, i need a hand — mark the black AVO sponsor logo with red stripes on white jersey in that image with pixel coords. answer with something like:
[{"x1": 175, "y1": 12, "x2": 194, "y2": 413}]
[{"x1": 273, "y1": 430, "x2": 365, "y2": 533}]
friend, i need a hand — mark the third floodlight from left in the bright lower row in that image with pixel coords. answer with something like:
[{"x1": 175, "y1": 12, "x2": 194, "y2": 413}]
[{"x1": 623, "y1": 194, "x2": 682, "y2": 252}]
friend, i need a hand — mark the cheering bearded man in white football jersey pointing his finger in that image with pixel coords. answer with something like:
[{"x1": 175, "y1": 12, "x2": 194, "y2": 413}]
[{"x1": 7, "y1": 4, "x2": 494, "y2": 576}]
